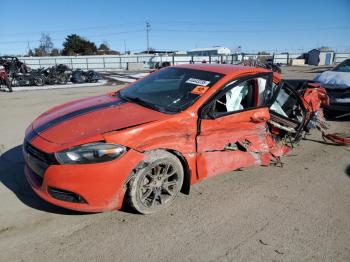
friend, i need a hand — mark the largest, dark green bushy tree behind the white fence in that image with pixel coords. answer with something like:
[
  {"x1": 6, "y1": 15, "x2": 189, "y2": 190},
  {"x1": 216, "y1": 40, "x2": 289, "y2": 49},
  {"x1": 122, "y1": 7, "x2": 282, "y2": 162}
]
[{"x1": 62, "y1": 34, "x2": 97, "y2": 55}]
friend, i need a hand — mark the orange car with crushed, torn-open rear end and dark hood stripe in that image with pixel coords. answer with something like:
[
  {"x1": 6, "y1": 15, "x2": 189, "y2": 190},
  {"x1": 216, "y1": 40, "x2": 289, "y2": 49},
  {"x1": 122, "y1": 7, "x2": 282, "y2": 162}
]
[{"x1": 23, "y1": 64, "x2": 328, "y2": 214}]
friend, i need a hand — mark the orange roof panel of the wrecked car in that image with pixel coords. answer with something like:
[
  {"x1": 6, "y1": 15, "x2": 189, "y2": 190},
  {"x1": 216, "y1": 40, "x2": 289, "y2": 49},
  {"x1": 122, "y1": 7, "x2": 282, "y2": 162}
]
[{"x1": 175, "y1": 63, "x2": 269, "y2": 75}]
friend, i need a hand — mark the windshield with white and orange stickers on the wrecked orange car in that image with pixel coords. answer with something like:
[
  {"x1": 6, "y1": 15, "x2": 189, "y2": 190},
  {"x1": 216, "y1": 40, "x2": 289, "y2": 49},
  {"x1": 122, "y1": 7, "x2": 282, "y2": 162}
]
[{"x1": 119, "y1": 67, "x2": 223, "y2": 113}]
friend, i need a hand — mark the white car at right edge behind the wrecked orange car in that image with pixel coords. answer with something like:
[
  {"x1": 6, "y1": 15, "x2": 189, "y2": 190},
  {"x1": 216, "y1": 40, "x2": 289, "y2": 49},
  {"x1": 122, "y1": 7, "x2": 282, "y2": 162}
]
[{"x1": 314, "y1": 59, "x2": 350, "y2": 118}]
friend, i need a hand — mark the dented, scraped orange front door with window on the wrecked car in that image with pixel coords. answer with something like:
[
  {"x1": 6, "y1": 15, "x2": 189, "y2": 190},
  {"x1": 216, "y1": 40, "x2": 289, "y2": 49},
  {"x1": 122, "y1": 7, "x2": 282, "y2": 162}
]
[{"x1": 197, "y1": 73, "x2": 274, "y2": 179}]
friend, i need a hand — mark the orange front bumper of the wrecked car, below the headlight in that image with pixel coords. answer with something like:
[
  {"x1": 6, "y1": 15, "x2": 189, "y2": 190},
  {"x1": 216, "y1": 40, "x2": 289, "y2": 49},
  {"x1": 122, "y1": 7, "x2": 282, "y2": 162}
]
[{"x1": 24, "y1": 143, "x2": 144, "y2": 212}]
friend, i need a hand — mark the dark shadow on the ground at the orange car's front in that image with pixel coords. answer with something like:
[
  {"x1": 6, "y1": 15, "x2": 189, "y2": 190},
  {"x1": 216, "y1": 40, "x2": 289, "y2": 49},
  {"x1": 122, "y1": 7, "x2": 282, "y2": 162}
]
[{"x1": 0, "y1": 145, "x2": 88, "y2": 215}]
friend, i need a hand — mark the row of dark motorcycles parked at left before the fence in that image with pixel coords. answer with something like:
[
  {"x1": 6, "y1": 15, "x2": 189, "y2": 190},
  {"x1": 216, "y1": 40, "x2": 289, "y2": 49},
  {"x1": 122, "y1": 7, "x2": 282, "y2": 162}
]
[{"x1": 0, "y1": 56, "x2": 101, "y2": 92}]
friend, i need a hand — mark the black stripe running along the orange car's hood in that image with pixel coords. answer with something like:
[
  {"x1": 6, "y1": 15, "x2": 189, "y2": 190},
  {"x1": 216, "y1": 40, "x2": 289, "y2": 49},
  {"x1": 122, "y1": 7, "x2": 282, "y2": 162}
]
[{"x1": 26, "y1": 100, "x2": 126, "y2": 141}]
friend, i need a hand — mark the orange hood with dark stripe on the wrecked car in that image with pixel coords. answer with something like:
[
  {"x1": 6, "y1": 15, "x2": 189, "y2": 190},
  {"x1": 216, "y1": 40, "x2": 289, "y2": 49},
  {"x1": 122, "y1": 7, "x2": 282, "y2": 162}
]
[{"x1": 28, "y1": 95, "x2": 167, "y2": 145}]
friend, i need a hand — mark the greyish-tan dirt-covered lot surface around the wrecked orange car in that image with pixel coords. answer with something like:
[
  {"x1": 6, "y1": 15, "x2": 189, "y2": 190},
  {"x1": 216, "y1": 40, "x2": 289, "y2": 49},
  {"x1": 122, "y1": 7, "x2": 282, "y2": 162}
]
[{"x1": 0, "y1": 68, "x2": 350, "y2": 262}]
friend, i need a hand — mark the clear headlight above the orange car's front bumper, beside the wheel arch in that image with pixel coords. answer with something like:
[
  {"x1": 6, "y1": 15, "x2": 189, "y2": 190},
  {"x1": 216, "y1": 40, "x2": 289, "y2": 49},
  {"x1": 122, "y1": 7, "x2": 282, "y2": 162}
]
[{"x1": 55, "y1": 142, "x2": 127, "y2": 164}]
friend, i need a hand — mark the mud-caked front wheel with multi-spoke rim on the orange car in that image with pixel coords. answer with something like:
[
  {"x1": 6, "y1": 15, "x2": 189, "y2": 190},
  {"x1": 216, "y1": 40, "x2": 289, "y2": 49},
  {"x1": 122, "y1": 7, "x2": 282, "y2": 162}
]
[{"x1": 127, "y1": 150, "x2": 184, "y2": 214}]
